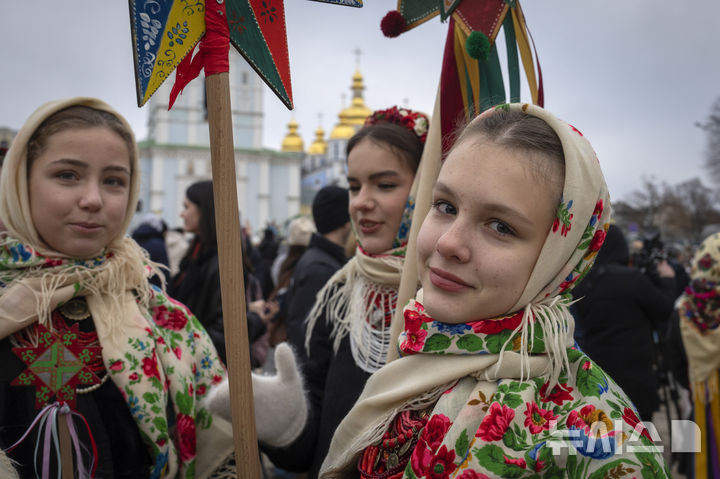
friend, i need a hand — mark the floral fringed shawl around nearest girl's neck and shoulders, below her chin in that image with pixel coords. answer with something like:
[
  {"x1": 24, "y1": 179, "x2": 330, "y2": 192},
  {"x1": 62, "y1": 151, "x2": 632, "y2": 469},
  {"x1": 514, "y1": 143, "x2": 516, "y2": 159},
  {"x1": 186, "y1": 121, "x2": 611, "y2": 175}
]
[{"x1": 321, "y1": 301, "x2": 669, "y2": 479}]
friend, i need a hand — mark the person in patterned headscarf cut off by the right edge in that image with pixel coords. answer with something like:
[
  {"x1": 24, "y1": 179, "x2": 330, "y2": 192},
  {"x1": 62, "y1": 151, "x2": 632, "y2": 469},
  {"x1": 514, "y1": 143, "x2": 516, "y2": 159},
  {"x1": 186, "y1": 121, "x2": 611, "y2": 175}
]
[{"x1": 677, "y1": 233, "x2": 720, "y2": 479}]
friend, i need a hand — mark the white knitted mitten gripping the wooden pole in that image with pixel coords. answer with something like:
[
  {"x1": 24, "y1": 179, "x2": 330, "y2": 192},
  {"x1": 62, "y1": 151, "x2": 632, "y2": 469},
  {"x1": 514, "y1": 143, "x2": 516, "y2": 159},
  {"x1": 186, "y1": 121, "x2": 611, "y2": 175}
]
[{"x1": 208, "y1": 343, "x2": 308, "y2": 447}]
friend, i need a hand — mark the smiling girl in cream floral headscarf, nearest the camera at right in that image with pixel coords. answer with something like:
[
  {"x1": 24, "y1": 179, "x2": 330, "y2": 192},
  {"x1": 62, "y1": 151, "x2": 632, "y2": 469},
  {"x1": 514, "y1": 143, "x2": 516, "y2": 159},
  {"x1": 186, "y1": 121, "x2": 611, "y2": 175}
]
[{"x1": 321, "y1": 104, "x2": 666, "y2": 479}]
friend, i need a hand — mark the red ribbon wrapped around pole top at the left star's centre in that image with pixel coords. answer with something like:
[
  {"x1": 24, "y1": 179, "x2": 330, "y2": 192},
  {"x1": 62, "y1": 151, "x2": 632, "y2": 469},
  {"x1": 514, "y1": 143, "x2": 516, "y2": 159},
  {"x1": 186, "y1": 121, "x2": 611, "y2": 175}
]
[{"x1": 168, "y1": 0, "x2": 230, "y2": 110}]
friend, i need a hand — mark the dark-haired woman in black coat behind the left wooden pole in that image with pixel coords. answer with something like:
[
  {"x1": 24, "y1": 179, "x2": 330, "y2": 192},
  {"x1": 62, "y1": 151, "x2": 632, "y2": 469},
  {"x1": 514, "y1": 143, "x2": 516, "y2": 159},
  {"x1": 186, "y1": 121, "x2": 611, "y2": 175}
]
[{"x1": 168, "y1": 180, "x2": 268, "y2": 366}]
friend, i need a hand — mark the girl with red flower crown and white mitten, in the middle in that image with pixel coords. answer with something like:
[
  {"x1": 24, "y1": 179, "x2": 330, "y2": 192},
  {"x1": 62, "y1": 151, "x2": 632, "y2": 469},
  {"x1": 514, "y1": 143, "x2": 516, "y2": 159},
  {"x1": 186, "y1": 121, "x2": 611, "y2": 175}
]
[{"x1": 208, "y1": 107, "x2": 429, "y2": 477}]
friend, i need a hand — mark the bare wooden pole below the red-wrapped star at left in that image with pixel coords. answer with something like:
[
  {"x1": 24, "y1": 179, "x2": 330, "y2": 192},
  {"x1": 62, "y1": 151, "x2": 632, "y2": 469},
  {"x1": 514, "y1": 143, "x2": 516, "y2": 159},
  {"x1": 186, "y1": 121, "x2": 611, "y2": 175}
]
[{"x1": 205, "y1": 72, "x2": 261, "y2": 479}]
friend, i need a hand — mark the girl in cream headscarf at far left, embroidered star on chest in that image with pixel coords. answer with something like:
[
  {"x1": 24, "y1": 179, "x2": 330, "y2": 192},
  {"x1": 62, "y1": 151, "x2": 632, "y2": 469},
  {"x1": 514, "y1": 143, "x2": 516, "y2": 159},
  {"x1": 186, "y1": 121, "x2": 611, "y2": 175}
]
[{"x1": 0, "y1": 98, "x2": 232, "y2": 478}]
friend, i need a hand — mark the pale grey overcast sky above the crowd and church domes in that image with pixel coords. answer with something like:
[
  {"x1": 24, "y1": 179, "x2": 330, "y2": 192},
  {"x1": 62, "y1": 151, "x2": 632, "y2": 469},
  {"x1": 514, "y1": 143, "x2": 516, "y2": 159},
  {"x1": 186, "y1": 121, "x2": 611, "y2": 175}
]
[{"x1": 0, "y1": 0, "x2": 720, "y2": 199}]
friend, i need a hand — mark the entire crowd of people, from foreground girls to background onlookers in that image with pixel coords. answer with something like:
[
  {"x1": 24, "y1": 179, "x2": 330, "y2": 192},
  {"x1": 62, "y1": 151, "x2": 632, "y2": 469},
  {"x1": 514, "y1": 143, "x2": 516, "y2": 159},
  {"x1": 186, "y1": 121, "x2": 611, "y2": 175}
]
[{"x1": 0, "y1": 98, "x2": 720, "y2": 479}]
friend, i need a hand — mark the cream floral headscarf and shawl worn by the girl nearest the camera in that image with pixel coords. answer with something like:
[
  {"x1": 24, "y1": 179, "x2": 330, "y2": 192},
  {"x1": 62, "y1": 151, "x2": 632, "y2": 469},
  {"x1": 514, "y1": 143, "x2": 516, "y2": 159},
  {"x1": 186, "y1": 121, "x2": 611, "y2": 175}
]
[{"x1": 321, "y1": 105, "x2": 669, "y2": 479}]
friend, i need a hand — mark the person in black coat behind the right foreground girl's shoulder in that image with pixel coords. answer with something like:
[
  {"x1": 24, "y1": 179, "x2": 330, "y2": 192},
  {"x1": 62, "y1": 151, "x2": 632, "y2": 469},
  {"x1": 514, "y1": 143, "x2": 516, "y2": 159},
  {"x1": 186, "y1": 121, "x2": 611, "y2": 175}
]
[{"x1": 573, "y1": 225, "x2": 675, "y2": 421}]
